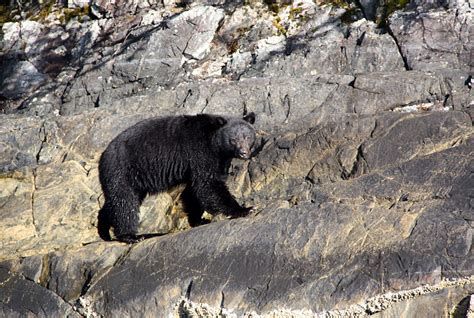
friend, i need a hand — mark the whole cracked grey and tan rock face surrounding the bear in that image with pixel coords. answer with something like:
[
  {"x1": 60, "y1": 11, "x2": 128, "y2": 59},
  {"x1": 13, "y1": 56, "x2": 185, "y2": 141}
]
[{"x1": 0, "y1": 0, "x2": 474, "y2": 317}]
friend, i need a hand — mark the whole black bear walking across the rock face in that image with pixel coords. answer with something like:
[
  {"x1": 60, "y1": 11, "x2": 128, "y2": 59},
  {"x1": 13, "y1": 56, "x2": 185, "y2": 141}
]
[{"x1": 98, "y1": 113, "x2": 255, "y2": 243}]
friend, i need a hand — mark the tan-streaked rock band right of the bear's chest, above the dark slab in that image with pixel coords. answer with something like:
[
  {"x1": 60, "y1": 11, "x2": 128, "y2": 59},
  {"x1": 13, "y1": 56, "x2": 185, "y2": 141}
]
[{"x1": 248, "y1": 112, "x2": 471, "y2": 200}]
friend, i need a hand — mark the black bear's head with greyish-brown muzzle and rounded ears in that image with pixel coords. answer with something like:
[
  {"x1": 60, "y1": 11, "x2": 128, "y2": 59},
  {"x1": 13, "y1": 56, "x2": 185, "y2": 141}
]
[{"x1": 214, "y1": 113, "x2": 256, "y2": 159}]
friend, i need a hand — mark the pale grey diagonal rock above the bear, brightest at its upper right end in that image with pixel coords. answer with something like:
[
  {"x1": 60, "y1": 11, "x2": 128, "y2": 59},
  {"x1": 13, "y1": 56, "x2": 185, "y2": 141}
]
[{"x1": 61, "y1": 6, "x2": 223, "y2": 115}]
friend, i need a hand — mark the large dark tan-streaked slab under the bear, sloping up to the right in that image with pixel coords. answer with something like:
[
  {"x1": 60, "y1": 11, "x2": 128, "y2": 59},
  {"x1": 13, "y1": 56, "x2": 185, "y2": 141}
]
[{"x1": 77, "y1": 140, "x2": 474, "y2": 316}]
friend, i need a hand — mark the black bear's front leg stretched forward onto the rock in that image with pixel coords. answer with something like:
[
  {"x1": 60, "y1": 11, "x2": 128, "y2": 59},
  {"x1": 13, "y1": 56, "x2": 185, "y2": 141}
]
[{"x1": 190, "y1": 178, "x2": 252, "y2": 217}]
